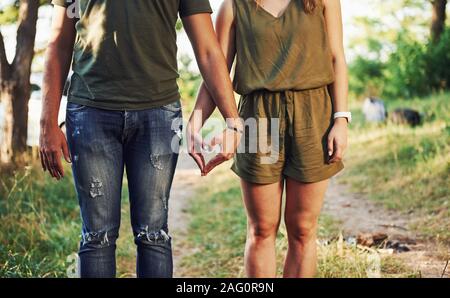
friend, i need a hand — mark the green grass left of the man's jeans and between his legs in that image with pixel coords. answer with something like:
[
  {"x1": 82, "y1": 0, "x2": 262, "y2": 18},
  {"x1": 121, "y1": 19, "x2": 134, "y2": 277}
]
[{"x1": 0, "y1": 164, "x2": 135, "y2": 277}]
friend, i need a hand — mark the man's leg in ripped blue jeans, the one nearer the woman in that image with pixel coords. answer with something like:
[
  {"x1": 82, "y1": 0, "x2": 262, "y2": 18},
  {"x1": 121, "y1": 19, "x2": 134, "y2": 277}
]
[{"x1": 124, "y1": 102, "x2": 182, "y2": 277}]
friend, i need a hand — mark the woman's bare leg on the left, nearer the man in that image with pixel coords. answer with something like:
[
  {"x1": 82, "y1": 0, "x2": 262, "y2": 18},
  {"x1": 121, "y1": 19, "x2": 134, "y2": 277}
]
[{"x1": 241, "y1": 180, "x2": 283, "y2": 277}]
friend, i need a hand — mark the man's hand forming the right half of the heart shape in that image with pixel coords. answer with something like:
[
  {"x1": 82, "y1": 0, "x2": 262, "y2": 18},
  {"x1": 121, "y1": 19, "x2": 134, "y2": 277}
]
[{"x1": 204, "y1": 128, "x2": 242, "y2": 175}]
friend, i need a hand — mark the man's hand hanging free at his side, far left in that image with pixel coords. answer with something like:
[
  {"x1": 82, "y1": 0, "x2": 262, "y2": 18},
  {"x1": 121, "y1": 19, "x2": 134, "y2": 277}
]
[{"x1": 39, "y1": 125, "x2": 71, "y2": 180}]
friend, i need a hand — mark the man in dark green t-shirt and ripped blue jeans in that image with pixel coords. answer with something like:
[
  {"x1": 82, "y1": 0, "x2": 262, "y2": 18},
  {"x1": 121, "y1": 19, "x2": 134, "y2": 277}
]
[{"x1": 40, "y1": 0, "x2": 241, "y2": 277}]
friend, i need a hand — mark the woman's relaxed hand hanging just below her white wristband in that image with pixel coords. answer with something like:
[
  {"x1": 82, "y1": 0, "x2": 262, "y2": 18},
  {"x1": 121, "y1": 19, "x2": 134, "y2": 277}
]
[{"x1": 328, "y1": 118, "x2": 348, "y2": 164}]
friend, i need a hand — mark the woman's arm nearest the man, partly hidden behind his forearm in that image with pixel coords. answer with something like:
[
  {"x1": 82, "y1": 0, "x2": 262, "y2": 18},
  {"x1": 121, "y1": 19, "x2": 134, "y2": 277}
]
[{"x1": 188, "y1": 0, "x2": 236, "y2": 169}]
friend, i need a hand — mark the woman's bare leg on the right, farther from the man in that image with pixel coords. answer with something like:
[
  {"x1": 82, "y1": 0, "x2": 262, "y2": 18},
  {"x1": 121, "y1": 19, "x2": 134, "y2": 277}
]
[{"x1": 284, "y1": 178, "x2": 329, "y2": 277}]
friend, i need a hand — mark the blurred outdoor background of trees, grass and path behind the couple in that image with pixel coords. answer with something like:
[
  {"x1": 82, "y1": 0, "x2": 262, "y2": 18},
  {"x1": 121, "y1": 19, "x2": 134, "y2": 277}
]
[{"x1": 0, "y1": 0, "x2": 450, "y2": 277}]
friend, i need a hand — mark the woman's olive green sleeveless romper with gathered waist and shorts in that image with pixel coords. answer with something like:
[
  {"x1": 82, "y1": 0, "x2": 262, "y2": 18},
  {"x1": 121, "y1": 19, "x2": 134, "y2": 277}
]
[{"x1": 232, "y1": 0, "x2": 343, "y2": 184}]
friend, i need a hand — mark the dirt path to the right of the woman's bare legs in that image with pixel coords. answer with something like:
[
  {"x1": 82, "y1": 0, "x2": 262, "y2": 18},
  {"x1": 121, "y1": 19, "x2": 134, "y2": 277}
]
[{"x1": 323, "y1": 181, "x2": 450, "y2": 277}]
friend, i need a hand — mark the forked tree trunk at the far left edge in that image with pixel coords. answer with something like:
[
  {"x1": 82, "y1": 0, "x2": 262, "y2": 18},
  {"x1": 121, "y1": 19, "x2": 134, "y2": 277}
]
[{"x1": 0, "y1": 0, "x2": 41, "y2": 164}]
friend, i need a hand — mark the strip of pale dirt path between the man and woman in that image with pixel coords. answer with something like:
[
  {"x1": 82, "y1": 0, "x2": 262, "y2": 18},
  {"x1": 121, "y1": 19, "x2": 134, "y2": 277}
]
[{"x1": 169, "y1": 153, "x2": 201, "y2": 277}]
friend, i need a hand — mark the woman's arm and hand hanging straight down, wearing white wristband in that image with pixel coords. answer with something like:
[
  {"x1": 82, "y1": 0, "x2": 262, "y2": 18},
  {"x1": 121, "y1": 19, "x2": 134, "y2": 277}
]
[{"x1": 323, "y1": 0, "x2": 348, "y2": 163}]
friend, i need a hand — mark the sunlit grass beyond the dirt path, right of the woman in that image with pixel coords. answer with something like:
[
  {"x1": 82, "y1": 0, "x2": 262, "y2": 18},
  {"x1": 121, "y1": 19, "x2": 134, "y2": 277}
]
[{"x1": 340, "y1": 93, "x2": 450, "y2": 244}]
